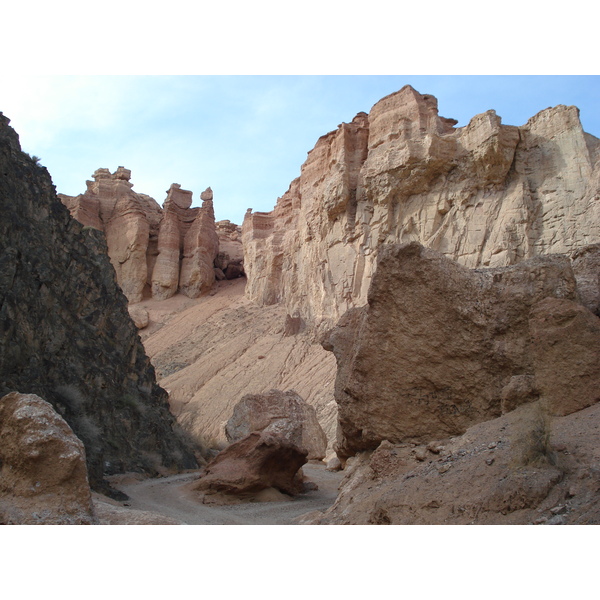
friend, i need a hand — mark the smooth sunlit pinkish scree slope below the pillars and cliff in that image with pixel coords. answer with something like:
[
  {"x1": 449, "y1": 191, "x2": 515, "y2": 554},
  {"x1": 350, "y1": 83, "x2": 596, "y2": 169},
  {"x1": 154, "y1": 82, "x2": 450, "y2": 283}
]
[{"x1": 142, "y1": 279, "x2": 337, "y2": 453}]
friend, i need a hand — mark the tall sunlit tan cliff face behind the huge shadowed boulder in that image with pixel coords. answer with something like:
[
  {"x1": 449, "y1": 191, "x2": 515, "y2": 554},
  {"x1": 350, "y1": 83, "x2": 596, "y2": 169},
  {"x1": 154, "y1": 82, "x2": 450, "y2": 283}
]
[{"x1": 242, "y1": 86, "x2": 600, "y2": 323}]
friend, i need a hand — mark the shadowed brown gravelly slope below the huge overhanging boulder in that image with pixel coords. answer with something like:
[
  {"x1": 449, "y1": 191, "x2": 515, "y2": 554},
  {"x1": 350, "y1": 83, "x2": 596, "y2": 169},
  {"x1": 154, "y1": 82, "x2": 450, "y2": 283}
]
[{"x1": 308, "y1": 403, "x2": 600, "y2": 525}]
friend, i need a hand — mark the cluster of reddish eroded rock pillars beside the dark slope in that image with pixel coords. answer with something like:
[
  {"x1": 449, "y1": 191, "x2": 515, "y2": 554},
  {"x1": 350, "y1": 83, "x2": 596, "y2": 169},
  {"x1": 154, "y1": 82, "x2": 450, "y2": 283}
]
[{"x1": 59, "y1": 176, "x2": 223, "y2": 304}]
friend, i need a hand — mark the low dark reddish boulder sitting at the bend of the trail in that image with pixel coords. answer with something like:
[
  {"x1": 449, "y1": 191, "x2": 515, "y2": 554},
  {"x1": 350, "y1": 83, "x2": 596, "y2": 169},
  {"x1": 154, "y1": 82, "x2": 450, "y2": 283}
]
[{"x1": 192, "y1": 431, "x2": 307, "y2": 502}]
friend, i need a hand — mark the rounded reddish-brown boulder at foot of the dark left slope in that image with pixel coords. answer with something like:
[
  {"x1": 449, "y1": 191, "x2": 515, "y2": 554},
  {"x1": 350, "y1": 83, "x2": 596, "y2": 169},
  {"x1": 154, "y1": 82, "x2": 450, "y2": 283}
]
[{"x1": 0, "y1": 392, "x2": 94, "y2": 525}]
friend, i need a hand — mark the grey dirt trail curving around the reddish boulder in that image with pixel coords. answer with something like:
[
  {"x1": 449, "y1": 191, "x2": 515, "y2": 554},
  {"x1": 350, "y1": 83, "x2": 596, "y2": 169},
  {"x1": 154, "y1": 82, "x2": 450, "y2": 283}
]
[{"x1": 109, "y1": 464, "x2": 343, "y2": 525}]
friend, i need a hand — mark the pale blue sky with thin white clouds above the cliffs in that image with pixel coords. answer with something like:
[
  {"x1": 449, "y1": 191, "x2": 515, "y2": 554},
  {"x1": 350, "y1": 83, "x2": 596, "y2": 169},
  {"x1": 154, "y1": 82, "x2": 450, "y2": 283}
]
[{"x1": 0, "y1": 74, "x2": 600, "y2": 223}]
